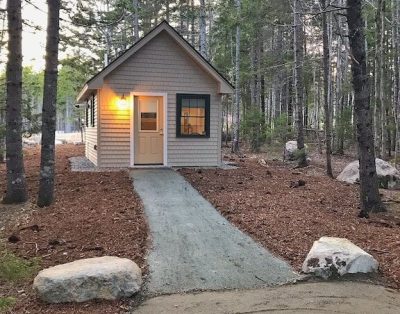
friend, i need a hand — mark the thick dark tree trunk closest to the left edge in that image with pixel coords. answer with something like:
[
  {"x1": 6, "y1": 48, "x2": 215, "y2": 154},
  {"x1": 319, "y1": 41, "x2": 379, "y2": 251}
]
[{"x1": 3, "y1": 0, "x2": 28, "y2": 204}]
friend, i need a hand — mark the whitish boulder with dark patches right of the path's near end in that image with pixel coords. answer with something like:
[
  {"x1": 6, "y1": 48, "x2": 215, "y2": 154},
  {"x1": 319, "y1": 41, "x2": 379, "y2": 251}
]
[{"x1": 302, "y1": 237, "x2": 378, "y2": 279}]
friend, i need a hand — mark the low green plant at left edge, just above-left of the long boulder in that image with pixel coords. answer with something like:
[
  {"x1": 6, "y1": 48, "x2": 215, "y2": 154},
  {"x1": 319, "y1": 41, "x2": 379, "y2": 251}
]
[{"x1": 0, "y1": 250, "x2": 39, "y2": 282}]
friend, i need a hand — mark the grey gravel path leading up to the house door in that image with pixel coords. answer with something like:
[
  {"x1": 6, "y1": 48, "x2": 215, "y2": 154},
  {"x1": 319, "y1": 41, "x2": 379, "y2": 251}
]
[{"x1": 131, "y1": 169, "x2": 297, "y2": 294}]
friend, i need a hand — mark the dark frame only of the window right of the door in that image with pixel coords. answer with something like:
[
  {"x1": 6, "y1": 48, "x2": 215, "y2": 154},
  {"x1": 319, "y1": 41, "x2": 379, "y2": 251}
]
[{"x1": 176, "y1": 94, "x2": 211, "y2": 138}]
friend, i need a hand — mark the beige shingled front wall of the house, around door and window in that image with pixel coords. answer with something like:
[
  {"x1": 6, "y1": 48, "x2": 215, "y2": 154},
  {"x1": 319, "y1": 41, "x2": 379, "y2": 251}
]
[{"x1": 99, "y1": 32, "x2": 222, "y2": 167}]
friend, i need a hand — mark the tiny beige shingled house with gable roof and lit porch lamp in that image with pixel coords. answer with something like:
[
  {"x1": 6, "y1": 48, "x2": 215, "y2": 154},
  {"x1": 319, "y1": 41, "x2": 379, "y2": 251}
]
[{"x1": 77, "y1": 21, "x2": 234, "y2": 168}]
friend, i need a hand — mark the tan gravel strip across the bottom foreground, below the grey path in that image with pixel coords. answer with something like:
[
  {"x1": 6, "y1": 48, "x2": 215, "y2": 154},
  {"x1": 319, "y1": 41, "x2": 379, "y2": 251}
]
[{"x1": 133, "y1": 282, "x2": 400, "y2": 314}]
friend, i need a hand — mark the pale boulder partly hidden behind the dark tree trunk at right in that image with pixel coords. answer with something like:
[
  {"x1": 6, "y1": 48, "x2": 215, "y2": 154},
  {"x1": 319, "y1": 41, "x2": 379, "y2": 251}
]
[{"x1": 336, "y1": 158, "x2": 400, "y2": 189}]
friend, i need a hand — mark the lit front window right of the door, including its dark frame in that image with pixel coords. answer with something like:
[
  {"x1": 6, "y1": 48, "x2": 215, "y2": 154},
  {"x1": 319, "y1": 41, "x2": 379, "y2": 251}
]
[{"x1": 176, "y1": 94, "x2": 210, "y2": 137}]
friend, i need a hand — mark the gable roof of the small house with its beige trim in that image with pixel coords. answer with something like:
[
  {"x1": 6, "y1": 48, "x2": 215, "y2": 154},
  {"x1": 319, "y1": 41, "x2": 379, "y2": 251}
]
[{"x1": 77, "y1": 21, "x2": 234, "y2": 102}]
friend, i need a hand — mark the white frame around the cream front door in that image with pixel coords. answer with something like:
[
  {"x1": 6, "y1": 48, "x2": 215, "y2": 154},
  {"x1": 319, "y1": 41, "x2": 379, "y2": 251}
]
[{"x1": 129, "y1": 91, "x2": 168, "y2": 168}]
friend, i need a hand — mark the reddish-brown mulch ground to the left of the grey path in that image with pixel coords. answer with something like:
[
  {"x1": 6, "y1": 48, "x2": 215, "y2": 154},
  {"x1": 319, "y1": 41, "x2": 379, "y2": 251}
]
[{"x1": 0, "y1": 145, "x2": 149, "y2": 313}]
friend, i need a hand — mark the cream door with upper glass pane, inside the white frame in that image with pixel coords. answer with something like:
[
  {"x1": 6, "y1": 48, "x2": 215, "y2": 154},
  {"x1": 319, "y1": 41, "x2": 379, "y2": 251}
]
[{"x1": 134, "y1": 96, "x2": 164, "y2": 165}]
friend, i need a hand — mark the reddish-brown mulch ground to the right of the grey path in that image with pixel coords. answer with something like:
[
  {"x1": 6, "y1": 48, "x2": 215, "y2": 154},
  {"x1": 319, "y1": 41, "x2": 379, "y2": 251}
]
[{"x1": 180, "y1": 144, "x2": 400, "y2": 289}]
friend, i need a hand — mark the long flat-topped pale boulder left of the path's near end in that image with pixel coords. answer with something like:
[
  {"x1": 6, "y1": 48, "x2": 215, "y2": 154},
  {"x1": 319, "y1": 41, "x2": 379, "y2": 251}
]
[{"x1": 33, "y1": 256, "x2": 142, "y2": 303}]
